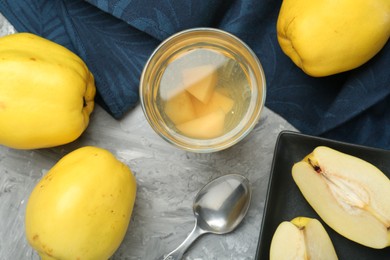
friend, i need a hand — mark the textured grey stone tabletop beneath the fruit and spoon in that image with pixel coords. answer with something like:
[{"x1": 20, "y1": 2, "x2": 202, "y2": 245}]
[{"x1": 0, "y1": 13, "x2": 295, "y2": 260}]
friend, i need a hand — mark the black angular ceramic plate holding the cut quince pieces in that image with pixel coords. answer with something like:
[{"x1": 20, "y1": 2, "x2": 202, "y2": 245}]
[{"x1": 256, "y1": 131, "x2": 390, "y2": 260}]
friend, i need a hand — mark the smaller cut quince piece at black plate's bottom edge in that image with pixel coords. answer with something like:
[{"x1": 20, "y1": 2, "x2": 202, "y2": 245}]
[{"x1": 270, "y1": 217, "x2": 338, "y2": 260}]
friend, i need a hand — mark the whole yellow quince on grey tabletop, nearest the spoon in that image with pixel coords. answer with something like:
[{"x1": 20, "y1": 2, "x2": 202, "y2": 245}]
[{"x1": 25, "y1": 146, "x2": 136, "y2": 260}]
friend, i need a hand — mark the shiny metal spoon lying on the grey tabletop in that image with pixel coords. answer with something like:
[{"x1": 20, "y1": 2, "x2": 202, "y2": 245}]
[{"x1": 164, "y1": 174, "x2": 251, "y2": 260}]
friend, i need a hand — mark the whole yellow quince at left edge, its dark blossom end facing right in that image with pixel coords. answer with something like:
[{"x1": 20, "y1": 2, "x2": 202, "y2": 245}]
[{"x1": 0, "y1": 33, "x2": 96, "y2": 149}]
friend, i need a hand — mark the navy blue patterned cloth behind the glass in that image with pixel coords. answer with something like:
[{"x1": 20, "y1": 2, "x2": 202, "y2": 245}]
[{"x1": 0, "y1": 0, "x2": 390, "y2": 149}]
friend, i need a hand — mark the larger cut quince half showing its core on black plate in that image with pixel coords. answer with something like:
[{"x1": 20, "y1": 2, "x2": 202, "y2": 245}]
[{"x1": 292, "y1": 146, "x2": 390, "y2": 249}]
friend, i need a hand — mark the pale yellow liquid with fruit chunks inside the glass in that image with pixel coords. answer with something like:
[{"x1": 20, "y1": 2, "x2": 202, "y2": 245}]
[{"x1": 156, "y1": 47, "x2": 251, "y2": 139}]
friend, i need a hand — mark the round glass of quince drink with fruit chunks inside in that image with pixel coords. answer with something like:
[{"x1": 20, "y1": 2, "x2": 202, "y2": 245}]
[{"x1": 140, "y1": 28, "x2": 265, "y2": 152}]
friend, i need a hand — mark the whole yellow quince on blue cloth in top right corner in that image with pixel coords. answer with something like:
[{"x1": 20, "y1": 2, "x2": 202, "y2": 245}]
[{"x1": 277, "y1": 0, "x2": 390, "y2": 77}]
